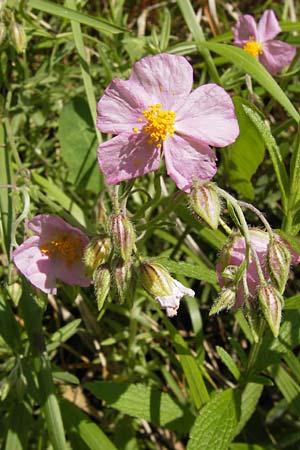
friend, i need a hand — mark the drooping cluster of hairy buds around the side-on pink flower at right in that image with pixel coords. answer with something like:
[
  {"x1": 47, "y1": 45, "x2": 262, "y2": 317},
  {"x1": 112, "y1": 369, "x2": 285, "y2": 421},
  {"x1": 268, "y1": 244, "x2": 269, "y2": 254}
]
[{"x1": 214, "y1": 228, "x2": 292, "y2": 337}]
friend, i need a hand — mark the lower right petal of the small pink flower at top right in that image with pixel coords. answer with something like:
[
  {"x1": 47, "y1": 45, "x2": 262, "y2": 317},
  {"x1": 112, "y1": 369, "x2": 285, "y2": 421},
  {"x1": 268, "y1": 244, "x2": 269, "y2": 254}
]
[{"x1": 259, "y1": 41, "x2": 296, "y2": 75}]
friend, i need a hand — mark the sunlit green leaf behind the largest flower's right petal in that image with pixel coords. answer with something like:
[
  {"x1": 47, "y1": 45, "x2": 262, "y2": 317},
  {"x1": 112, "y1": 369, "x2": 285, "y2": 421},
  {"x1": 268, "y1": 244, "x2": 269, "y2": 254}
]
[{"x1": 222, "y1": 97, "x2": 265, "y2": 199}]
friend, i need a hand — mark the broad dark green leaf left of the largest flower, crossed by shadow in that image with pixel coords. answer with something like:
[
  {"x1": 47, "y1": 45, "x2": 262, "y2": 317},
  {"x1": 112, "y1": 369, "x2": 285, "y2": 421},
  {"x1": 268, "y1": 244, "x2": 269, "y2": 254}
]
[{"x1": 58, "y1": 97, "x2": 102, "y2": 193}]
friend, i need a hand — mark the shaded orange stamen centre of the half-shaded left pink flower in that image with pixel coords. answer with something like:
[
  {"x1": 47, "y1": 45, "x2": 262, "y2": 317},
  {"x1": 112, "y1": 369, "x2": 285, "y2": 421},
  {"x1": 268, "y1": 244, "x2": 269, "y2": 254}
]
[{"x1": 40, "y1": 235, "x2": 83, "y2": 265}]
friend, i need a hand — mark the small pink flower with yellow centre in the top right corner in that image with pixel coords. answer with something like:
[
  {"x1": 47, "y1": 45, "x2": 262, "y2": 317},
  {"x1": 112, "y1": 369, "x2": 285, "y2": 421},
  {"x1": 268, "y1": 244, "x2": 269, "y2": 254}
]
[{"x1": 233, "y1": 9, "x2": 296, "y2": 75}]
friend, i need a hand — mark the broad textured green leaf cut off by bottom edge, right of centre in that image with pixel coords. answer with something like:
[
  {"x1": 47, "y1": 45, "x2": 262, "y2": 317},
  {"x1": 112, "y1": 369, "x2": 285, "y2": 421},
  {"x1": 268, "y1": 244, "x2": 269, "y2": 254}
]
[{"x1": 187, "y1": 389, "x2": 240, "y2": 450}]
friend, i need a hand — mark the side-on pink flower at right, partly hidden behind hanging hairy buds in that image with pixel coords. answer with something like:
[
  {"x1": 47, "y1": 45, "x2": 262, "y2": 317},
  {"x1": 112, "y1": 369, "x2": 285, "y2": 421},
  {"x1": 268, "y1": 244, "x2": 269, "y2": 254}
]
[{"x1": 216, "y1": 228, "x2": 300, "y2": 308}]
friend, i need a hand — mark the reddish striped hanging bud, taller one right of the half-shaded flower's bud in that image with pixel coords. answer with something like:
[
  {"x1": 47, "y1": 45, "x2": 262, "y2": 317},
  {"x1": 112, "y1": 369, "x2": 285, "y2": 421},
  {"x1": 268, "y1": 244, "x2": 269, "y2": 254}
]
[{"x1": 109, "y1": 213, "x2": 135, "y2": 263}]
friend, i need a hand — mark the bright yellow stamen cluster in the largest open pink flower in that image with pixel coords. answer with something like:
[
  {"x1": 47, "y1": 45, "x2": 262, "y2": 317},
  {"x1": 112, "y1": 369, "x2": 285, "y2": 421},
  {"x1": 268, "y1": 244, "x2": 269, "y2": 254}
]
[{"x1": 133, "y1": 104, "x2": 176, "y2": 148}]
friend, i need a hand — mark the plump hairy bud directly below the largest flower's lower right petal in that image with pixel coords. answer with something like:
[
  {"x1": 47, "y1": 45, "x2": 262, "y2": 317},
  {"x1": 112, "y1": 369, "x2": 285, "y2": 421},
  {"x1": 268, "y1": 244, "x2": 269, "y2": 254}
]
[{"x1": 189, "y1": 183, "x2": 221, "y2": 230}]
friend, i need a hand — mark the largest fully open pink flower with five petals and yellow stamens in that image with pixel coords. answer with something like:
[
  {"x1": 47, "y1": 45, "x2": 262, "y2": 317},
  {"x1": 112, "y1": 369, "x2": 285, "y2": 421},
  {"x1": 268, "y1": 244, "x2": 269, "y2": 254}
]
[{"x1": 97, "y1": 54, "x2": 239, "y2": 192}]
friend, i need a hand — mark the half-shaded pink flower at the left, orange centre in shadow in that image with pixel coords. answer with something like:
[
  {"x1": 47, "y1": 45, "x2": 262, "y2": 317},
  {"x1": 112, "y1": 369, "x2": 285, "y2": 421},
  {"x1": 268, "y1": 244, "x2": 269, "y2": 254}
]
[{"x1": 13, "y1": 214, "x2": 91, "y2": 294}]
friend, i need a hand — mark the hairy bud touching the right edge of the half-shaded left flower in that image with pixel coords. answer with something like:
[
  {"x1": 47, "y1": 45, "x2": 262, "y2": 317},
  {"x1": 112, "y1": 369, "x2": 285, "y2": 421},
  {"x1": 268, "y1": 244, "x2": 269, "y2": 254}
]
[{"x1": 84, "y1": 234, "x2": 111, "y2": 275}]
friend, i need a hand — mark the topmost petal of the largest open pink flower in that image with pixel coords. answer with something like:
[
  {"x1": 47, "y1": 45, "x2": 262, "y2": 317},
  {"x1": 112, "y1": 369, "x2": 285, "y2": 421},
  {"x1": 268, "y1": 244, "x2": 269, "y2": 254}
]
[{"x1": 130, "y1": 53, "x2": 193, "y2": 111}]
